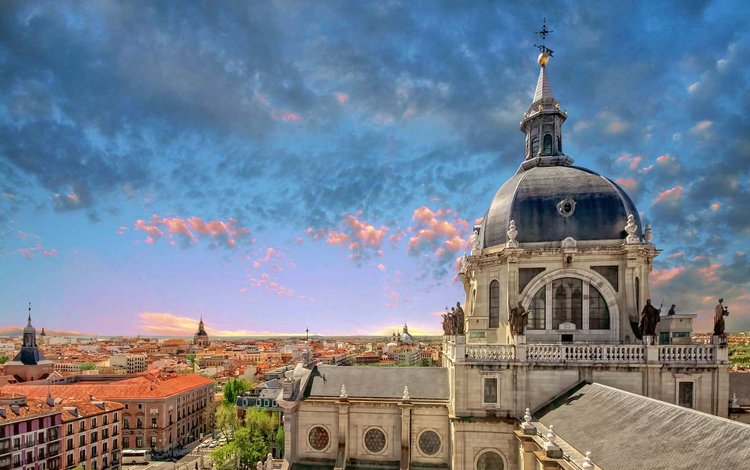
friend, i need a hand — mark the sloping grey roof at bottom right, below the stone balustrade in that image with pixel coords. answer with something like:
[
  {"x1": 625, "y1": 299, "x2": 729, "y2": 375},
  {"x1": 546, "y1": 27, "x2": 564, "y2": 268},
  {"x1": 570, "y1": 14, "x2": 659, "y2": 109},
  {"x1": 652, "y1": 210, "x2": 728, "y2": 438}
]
[{"x1": 536, "y1": 383, "x2": 750, "y2": 470}]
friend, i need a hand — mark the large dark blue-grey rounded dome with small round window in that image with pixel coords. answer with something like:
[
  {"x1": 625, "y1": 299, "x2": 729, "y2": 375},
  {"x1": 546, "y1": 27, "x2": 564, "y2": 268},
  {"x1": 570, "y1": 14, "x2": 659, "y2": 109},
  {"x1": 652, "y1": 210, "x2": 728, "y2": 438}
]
[{"x1": 480, "y1": 157, "x2": 641, "y2": 248}]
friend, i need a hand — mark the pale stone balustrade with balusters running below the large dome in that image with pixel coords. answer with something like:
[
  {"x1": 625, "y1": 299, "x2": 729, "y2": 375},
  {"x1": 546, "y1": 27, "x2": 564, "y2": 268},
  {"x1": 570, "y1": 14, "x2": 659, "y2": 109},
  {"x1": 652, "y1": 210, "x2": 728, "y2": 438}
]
[{"x1": 443, "y1": 337, "x2": 728, "y2": 365}]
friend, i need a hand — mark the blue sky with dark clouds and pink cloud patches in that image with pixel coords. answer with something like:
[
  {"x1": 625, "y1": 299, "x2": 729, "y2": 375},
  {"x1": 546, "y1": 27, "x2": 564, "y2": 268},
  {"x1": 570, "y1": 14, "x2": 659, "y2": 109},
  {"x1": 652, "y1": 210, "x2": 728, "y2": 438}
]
[{"x1": 0, "y1": 0, "x2": 750, "y2": 336}]
